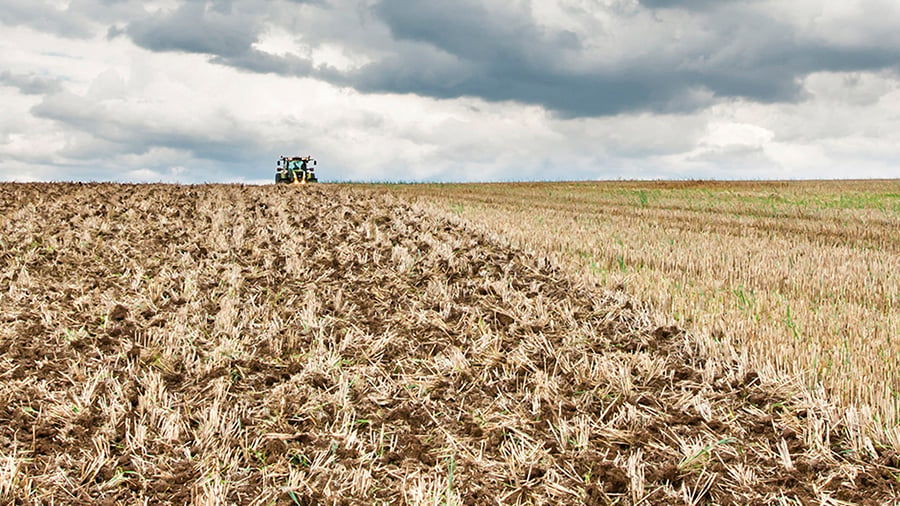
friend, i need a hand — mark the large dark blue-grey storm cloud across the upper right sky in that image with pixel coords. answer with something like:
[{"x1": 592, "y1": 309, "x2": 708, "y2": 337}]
[{"x1": 355, "y1": 0, "x2": 900, "y2": 116}]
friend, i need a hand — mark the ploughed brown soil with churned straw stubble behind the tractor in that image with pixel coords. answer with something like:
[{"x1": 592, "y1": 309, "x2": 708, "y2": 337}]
[{"x1": 0, "y1": 184, "x2": 900, "y2": 505}]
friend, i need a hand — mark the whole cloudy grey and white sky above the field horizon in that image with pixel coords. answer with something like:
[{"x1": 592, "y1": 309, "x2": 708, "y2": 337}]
[{"x1": 0, "y1": 0, "x2": 900, "y2": 183}]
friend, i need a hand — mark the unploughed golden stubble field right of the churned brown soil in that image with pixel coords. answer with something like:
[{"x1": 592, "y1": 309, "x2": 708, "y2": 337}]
[{"x1": 391, "y1": 180, "x2": 900, "y2": 440}]
